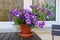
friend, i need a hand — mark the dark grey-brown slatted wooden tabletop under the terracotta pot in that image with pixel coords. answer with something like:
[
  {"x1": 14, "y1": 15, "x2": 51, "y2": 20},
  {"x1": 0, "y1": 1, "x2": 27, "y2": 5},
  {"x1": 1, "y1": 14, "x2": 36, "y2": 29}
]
[{"x1": 0, "y1": 32, "x2": 41, "y2": 40}]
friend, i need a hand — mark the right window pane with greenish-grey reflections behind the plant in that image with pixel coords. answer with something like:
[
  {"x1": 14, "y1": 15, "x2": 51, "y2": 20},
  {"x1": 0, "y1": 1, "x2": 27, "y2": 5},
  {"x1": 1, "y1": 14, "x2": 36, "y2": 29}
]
[{"x1": 32, "y1": 0, "x2": 56, "y2": 21}]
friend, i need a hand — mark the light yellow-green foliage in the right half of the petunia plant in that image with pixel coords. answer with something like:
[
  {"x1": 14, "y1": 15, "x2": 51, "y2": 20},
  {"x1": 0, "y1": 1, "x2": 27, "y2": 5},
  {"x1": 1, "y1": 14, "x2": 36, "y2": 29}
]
[{"x1": 32, "y1": 5, "x2": 46, "y2": 21}]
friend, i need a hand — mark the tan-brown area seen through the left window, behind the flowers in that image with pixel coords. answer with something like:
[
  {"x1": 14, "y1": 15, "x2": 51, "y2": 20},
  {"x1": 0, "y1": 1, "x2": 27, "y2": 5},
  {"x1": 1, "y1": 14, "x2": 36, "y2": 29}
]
[{"x1": 0, "y1": 0, "x2": 23, "y2": 21}]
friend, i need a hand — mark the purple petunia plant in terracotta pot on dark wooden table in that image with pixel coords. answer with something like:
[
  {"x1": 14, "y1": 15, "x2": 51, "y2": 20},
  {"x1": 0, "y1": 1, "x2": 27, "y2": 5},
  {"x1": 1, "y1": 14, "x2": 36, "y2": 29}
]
[{"x1": 9, "y1": 5, "x2": 51, "y2": 34}]
